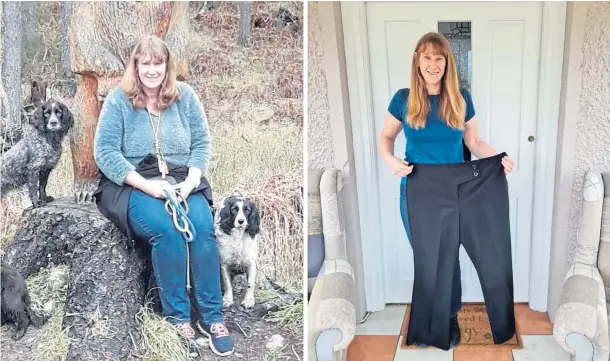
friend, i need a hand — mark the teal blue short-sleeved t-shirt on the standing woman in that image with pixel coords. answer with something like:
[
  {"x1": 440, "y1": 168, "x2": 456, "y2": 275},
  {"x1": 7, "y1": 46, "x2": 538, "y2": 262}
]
[{"x1": 388, "y1": 88, "x2": 475, "y2": 164}]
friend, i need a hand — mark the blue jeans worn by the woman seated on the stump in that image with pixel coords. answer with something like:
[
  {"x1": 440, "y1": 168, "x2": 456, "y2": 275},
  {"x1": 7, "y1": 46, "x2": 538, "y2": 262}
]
[{"x1": 129, "y1": 189, "x2": 224, "y2": 325}]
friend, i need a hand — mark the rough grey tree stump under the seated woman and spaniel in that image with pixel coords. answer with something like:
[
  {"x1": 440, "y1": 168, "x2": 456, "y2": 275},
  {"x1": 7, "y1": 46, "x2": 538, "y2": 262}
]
[{"x1": 5, "y1": 199, "x2": 151, "y2": 361}]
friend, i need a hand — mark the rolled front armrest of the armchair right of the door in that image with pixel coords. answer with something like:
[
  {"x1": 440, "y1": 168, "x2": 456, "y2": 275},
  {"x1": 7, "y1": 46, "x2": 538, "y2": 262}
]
[{"x1": 553, "y1": 263, "x2": 608, "y2": 361}]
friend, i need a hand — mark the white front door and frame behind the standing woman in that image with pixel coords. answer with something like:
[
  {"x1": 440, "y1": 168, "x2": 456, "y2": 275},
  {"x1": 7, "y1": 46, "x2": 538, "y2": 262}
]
[{"x1": 366, "y1": 2, "x2": 542, "y2": 303}]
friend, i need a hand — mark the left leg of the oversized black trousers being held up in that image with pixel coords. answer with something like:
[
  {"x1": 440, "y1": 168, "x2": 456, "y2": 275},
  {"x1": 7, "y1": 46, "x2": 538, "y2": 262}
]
[{"x1": 406, "y1": 178, "x2": 459, "y2": 350}]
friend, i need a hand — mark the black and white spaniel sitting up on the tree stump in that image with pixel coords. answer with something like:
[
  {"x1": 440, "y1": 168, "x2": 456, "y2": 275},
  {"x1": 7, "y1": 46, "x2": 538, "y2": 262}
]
[{"x1": 0, "y1": 100, "x2": 74, "y2": 207}]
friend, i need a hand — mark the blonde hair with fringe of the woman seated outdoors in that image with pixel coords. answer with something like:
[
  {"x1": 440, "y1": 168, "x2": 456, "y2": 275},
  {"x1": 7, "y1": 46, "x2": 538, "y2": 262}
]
[{"x1": 120, "y1": 35, "x2": 179, "y2": 109}]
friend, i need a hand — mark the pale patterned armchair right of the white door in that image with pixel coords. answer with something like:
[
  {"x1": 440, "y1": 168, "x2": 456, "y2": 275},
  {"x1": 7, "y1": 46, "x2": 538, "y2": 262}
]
[{"x1": 553, "y1": 171, "x2": 610, "y2": 361}]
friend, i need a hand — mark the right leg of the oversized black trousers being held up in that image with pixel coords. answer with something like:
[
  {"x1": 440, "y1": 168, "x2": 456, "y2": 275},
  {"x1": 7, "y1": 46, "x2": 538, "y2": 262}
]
[{"x1": 459, "y1": 163, "x2": 515, "y2": 344}]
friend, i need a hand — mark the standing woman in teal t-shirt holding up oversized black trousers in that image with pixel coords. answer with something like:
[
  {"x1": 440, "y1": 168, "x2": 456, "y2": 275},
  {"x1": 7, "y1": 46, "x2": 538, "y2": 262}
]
[{"x1": 379, "y1": 32, "x2": 514, "y2": 347}]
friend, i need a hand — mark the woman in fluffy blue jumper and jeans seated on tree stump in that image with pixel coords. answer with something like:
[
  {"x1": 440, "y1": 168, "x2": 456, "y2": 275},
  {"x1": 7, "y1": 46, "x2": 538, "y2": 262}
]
[{"x1": 94, "y1": 36, "x2": 233, "y2": 355}]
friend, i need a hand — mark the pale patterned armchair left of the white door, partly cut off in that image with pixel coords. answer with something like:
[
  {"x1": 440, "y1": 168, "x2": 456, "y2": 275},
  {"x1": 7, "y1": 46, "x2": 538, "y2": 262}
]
[{"x1": 307, "y1": 169, "x2": 356, "y2": 361}]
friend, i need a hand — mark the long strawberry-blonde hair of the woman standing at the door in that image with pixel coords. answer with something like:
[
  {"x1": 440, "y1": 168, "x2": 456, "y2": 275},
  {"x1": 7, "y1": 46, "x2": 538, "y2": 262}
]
[{"x1": 407, "y1": 32, "x2": 466, "y2": 129}]
